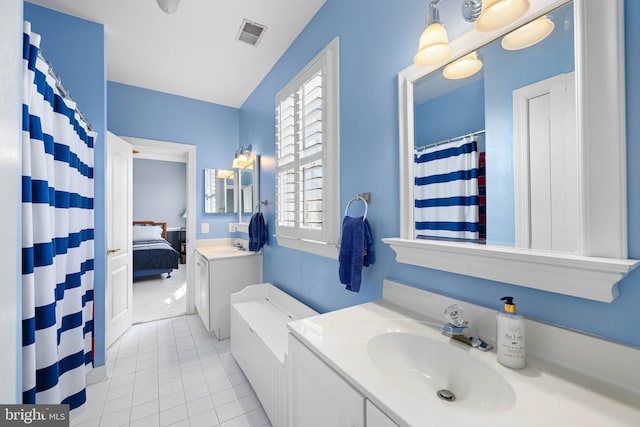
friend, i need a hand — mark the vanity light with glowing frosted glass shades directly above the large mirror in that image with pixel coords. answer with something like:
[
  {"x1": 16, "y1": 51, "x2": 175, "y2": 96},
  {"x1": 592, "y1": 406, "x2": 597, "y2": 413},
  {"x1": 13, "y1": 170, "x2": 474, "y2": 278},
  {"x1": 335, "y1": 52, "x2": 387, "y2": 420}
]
[{"x1": 413, "y1": 0, "x2": 531, "y2": 67}]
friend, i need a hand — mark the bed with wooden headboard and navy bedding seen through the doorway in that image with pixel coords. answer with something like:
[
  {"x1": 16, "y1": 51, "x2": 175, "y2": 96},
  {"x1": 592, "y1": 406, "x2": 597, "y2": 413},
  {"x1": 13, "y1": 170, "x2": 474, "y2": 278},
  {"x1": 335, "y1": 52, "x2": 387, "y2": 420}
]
[{"x1": 133, "y1": 221, "x2": 180, "y2": 279}]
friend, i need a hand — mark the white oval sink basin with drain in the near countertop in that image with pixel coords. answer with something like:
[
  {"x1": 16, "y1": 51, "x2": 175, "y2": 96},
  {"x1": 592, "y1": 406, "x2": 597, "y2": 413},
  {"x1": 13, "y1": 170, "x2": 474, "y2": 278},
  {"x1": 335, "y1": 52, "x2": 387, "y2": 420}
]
[{"x1": 367, "y1": 332, "x2": 516, "y2": 413}]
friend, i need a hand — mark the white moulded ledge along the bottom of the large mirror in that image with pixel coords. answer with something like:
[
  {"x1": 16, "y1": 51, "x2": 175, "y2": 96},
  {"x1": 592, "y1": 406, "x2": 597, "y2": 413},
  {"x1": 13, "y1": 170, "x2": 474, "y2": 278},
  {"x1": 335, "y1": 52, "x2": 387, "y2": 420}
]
[{"x1": 382, "y1": 238, "x2": 640, "y2": 302}]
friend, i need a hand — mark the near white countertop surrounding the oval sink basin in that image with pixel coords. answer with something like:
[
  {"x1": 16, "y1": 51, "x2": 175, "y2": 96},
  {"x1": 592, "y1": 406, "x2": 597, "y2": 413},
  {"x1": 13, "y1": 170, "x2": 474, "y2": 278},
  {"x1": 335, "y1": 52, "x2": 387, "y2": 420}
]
[{"x1": 288, "y1": 300, "x2": 640, "y2": 427}]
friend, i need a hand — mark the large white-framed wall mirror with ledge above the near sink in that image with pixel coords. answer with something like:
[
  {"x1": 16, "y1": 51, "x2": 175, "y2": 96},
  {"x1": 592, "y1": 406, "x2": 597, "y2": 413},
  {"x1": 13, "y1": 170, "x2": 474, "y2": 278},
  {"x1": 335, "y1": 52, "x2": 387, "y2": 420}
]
[{"x1": 384, "y1": 0, "x2": 636, "y2": 301}]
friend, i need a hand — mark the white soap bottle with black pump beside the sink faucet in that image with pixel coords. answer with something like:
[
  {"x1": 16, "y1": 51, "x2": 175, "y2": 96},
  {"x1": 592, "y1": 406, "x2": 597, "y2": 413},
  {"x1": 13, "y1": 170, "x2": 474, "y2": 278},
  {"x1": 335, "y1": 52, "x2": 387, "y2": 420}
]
[{"x1": 496, "y1": 297, "x2": 525, "y2": 369}]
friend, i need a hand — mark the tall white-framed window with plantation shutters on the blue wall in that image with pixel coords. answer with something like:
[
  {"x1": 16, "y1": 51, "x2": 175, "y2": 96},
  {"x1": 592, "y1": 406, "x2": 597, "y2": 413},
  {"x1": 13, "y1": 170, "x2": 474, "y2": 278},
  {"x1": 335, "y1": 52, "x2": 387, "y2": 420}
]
[{"x1": 276, "y1": 38, "x2": 340, "y2": 257}]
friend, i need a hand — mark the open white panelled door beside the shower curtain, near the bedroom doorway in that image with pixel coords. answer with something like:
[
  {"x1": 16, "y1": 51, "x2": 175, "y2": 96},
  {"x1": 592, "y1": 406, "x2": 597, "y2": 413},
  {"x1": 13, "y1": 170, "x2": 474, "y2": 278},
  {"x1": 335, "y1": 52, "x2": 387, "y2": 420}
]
[{"x1": 105, "y1": 132, "x2": 133, "y2": 347}]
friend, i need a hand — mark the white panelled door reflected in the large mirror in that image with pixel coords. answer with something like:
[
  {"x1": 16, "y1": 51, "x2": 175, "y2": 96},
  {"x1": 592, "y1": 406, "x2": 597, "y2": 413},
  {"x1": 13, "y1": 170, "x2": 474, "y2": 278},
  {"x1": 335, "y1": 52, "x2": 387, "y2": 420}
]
[{"x1": 513, "y1": 73, "x2": 580, "y2": 253}]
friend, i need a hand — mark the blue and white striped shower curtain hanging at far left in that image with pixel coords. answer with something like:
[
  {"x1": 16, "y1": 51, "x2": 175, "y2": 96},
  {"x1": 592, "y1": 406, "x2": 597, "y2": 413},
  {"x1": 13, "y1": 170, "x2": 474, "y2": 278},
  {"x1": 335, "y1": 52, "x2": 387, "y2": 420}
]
[{"x1": 22, "y1": 22, "x2": 96, "y2": 410}]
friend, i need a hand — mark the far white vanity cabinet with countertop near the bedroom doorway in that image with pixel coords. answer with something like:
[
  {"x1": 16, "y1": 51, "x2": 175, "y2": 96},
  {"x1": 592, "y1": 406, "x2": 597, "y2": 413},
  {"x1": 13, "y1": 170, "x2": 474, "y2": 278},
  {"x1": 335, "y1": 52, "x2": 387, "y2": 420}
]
[{"x1": 195, "y1": 247, "x2": 262, "y2": 340}]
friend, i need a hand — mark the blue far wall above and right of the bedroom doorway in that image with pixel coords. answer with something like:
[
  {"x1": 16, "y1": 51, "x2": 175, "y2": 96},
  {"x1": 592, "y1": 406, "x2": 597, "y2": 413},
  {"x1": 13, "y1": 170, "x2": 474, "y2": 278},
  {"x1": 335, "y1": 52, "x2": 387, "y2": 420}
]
[{"x1": 107, "y1": 81, "x2": 240, "y2": 239}]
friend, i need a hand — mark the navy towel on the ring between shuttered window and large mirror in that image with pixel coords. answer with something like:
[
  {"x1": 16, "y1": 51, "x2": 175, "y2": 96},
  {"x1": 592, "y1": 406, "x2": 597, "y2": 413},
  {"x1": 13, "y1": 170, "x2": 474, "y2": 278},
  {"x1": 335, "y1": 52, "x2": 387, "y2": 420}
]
[{"x1": 338, "y1": 216, "x2": 376, "y2": 292}]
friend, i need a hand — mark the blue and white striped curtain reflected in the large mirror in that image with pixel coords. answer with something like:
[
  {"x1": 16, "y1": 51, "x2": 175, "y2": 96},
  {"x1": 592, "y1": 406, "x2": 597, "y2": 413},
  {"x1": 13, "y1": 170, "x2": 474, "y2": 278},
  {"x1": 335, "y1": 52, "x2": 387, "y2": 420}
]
[{"x1": 413, "y1": 138, "x2": 479, "y2": 241}]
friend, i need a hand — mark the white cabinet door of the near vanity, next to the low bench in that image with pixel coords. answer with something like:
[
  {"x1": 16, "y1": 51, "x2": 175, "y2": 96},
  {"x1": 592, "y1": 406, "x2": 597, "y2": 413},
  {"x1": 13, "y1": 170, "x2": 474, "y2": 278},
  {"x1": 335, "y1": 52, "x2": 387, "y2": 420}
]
[{"x1": 289, "y1": 335, "x2": 365, "y2": 427}]
